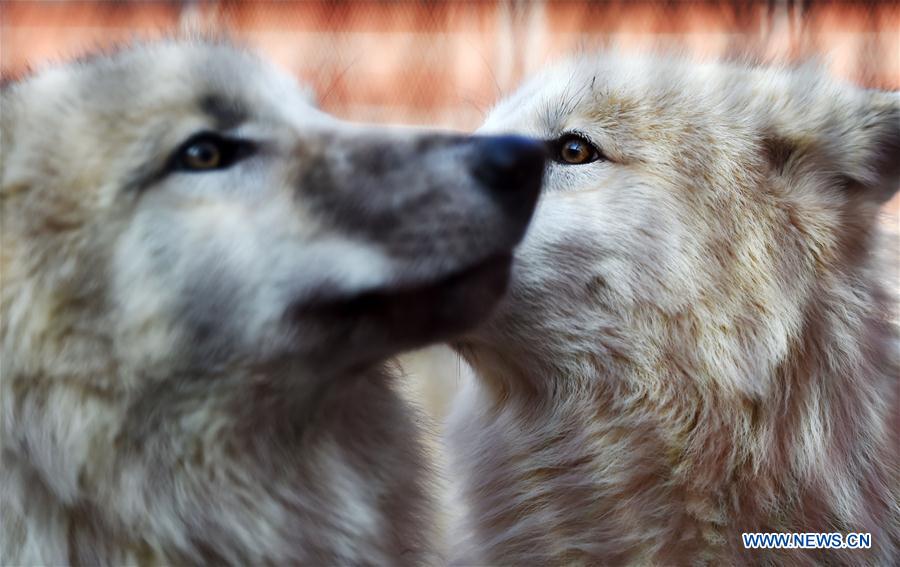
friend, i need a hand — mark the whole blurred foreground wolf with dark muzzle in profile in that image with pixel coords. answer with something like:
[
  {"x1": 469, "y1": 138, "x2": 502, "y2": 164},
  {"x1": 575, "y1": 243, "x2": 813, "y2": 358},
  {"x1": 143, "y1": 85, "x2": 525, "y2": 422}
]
[{"x1": 0, "y1": 40, "x2": 544, "y2": 565}]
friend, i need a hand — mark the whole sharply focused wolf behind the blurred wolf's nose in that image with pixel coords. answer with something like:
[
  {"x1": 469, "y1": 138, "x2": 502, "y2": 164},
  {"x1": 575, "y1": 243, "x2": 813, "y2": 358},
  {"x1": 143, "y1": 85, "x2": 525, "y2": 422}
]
[{"x1": 450, "y1": 53, "x2": 900, "y2": 565}]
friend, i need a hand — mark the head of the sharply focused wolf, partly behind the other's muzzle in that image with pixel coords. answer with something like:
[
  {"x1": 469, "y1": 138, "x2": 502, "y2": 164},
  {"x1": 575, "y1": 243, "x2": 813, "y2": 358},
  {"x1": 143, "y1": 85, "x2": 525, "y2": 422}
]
[{"x1": 474, "y1": 56, "x2": 900, "y2": 400}]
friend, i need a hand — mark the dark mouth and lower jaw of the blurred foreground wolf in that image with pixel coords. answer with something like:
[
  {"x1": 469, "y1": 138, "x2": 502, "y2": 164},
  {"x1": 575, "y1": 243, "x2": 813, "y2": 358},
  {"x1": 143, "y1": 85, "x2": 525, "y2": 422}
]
[{"x1": 294, "y1": 253, "x2": 512, "y2": 345}]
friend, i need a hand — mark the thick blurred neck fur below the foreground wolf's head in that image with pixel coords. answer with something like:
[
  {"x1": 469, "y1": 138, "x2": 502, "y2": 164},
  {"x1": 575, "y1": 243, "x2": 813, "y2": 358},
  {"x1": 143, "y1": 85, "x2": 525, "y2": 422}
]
[{"x1": 0, "y1": 362, "x2": 433, "y2": 565}]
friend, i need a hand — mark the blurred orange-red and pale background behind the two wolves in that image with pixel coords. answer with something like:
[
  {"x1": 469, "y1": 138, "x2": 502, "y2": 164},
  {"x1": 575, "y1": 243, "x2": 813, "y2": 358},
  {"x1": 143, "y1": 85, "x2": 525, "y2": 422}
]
[{"x1": 0, "y1": 0, "x2": 900, "y2": 418}]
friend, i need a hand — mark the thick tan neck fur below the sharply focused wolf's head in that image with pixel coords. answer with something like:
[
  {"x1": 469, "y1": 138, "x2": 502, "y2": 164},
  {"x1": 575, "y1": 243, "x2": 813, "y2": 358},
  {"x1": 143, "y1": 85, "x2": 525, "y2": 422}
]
[{"x1": 452, "y1": 258, "x2": 900, "y2": 565}]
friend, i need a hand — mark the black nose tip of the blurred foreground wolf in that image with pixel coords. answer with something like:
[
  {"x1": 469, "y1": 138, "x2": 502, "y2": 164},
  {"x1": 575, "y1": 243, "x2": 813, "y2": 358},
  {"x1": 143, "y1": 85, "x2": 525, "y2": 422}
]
[{"x1": 473, "y1": 136, "x2": 547, "y2": 209}]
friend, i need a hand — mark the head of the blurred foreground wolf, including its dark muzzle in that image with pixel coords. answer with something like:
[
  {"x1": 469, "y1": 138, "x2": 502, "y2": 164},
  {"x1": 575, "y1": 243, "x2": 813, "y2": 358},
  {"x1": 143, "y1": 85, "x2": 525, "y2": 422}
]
[{"x1": 0, "y1": 41, "x2": 544, "y2": 524}]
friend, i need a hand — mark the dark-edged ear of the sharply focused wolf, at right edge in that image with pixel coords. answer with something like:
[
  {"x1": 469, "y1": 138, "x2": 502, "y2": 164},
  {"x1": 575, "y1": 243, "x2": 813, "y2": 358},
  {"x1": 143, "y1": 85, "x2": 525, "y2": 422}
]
[{"x1": 840, "y1": 91, "x2": 900, "y2": 207}]
